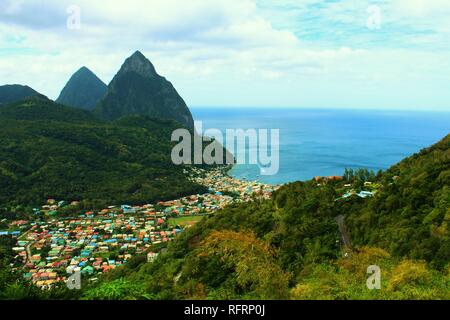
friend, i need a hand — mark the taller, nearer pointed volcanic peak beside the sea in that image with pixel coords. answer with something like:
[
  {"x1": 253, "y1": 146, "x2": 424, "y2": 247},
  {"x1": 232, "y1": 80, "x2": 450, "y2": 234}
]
[{"x1": 94, "y1": 51, "x2": 194, "y2": 130}]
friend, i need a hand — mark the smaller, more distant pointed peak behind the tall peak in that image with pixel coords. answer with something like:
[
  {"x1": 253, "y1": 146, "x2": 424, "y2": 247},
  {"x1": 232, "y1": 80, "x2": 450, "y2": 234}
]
[{"x1": 56, "y1": 67, "x2": 108, "y2": 110}]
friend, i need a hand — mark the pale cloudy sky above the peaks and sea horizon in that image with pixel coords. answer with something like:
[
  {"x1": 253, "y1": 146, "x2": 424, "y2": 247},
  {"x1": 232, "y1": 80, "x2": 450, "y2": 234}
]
[{"x1": 0, "y1": 0, "x2": 450, "y2": 111}]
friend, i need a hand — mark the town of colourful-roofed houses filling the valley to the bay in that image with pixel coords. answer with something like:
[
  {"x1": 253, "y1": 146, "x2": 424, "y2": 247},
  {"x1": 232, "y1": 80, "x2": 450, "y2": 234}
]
[{"x1": 0, "y1": 169, "x2": 279, "y2": 289}]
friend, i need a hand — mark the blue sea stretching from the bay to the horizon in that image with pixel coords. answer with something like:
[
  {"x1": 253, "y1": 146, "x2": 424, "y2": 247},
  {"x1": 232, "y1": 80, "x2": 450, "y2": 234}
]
[{"x1": 192, "y1": 107, "x2": 450, "y2": 184}]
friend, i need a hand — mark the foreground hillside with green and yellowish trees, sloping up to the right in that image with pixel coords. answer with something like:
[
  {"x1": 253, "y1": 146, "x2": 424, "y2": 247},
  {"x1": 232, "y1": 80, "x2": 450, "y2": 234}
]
[{"x1": 82, "y1": 136, "x2": 450, "y2": 299}]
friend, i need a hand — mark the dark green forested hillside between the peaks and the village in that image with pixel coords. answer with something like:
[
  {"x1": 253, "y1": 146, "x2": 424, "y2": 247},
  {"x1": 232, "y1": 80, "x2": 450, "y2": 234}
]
[{"x1": 0, "y1": 97, "x2": 204, "y2": 206}]
